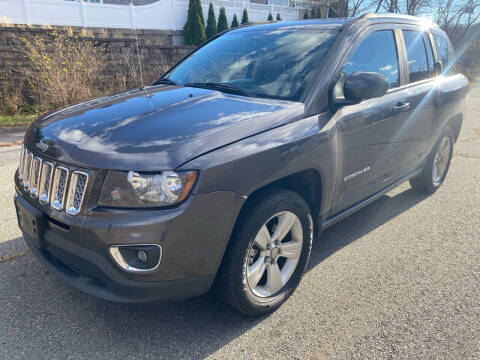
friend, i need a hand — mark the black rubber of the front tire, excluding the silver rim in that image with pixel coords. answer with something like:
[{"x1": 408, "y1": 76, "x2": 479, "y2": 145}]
[{"x1": 216, "y1": 189, "x2": 313, "y2": 316}]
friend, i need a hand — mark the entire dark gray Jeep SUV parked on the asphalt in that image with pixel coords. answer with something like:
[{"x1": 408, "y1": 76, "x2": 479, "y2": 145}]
[{"x1": 15, "y1": 15, "x2": 469, "y2": 315}]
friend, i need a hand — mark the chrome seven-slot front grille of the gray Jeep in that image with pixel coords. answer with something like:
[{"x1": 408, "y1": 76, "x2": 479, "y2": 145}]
[{"x1": 18, "y1": 146, "x2": 89, "y2": 215}]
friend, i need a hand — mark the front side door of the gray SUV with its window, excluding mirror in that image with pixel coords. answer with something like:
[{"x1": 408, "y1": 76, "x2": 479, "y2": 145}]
[{"x1": 332, "y1": 26, "x2": 410, "y2": 214}]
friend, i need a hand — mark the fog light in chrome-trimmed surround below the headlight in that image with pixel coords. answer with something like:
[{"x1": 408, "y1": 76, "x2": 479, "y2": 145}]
[{"x1": 110, "y1": 244, "x2": 162, "y2": 273}]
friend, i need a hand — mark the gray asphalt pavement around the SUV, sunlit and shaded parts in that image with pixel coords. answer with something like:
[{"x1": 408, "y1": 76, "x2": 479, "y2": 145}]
[{"x1": 0, "y1": 86, "x2": 480, "y2": 360}]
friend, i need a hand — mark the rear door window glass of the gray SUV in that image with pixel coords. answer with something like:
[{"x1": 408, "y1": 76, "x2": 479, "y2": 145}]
[{"x1": 402, "y1": 30, "x2": 429, "y2": 83}]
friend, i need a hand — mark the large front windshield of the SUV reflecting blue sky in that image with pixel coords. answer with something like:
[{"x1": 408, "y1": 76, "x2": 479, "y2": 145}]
[{"x1": 163, "y1": 29, "x2": 337, "y2": 101}]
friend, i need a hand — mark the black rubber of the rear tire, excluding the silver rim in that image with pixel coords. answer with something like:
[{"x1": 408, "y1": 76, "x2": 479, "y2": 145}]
[{"x1": 410, "y1": 126, "x2": 455, "y2": 194}]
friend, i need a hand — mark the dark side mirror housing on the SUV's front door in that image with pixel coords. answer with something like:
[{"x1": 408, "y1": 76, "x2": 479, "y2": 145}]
[{"x1": 343, "y1": 71, "x2": 389, "y2": 102}]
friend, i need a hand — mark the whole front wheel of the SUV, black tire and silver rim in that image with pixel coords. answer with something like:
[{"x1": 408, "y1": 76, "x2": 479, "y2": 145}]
[{"x1": 216, "y1": 189, "x2": 313, "y2": 316}]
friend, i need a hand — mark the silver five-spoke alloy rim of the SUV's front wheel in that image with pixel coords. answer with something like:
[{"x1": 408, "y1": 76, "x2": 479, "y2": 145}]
[{"x1": 246, "y1": 211, "x2": 303, "y2": 297}]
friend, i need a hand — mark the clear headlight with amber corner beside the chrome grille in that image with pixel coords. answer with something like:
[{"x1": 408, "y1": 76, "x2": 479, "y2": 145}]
[{"x1": 98, "y1": 171, "x2": 197, "y2": 207}]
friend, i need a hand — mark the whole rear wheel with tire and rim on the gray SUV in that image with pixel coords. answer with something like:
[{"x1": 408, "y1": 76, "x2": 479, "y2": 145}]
[{"x1": 410, "y1": 126, "x2": 455, "y2": 194}]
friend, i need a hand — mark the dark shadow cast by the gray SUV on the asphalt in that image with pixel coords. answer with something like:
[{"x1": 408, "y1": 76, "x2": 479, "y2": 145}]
[{"x1": 0, "y1": 184, "x2": 426, "y2": 359}]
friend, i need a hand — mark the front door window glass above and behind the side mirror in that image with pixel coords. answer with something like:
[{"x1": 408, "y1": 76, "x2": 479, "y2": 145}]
[{"x1": 343, "y1": 30, "x2": 400, "y2": 88}]
